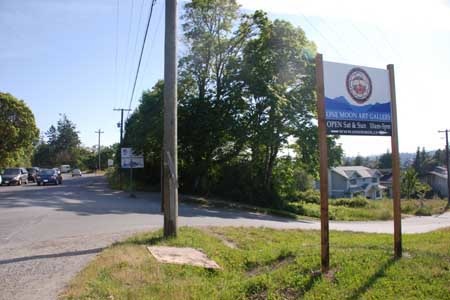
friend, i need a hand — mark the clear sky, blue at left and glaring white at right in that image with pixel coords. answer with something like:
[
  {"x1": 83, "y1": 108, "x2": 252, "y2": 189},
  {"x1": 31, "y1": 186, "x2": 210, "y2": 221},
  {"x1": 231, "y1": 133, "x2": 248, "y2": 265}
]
[{"x1": 0, "y1": 0, "x2": 450, "y2": 155}]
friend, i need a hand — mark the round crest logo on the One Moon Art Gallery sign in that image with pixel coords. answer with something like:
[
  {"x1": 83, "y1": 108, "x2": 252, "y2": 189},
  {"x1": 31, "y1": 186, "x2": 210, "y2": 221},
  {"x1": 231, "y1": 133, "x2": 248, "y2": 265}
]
[{"x1": 345, "y1": 68, "x2": 372, "y2": 104}]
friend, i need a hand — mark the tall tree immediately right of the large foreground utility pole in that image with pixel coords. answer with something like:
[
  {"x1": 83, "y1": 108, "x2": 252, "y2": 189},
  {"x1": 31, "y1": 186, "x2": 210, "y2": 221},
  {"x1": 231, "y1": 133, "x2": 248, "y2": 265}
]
[{"x1": 179, "y1": 0, "x2": 249, "y2": 192}]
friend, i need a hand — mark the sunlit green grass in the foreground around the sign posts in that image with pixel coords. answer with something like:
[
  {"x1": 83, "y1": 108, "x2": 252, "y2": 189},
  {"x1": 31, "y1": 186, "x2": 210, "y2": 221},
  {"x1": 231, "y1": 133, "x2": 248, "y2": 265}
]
[{"x1": 61, "y1": 228, "x2": 450, "y2": 300}]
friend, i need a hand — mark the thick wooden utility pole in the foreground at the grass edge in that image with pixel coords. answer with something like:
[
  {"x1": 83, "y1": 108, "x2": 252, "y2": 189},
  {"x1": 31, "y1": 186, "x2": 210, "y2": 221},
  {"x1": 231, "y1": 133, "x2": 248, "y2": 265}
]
[{"x1": 163, "y1": 0, "x2": 178, "y2": 237}]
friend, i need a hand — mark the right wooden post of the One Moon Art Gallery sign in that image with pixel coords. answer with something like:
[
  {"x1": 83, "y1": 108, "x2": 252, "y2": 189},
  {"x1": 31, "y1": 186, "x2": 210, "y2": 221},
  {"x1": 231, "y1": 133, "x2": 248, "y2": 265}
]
[{"x1": 387, "y1": 65, "x2": 402, "y2": 258}]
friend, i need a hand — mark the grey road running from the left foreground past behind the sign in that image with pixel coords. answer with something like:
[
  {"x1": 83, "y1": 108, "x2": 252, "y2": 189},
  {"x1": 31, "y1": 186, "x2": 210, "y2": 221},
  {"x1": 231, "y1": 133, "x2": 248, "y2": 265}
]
[{"x1": 0, "y1": 176, "x2": 450, "y2": 300}]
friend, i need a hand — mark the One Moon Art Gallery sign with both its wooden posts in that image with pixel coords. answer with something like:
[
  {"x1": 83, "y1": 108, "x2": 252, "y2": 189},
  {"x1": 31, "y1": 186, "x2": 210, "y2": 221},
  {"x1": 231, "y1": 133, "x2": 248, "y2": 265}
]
[{"x1": 315, "y1": 54, "x2": 402, "y2": 273}]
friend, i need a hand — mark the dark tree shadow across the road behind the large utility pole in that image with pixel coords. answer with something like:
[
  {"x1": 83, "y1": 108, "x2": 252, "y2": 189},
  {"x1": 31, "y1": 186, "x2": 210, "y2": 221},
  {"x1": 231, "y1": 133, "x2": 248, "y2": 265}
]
[{"x1": 0, "y1": 176, "x2": 309, "y2": 223}]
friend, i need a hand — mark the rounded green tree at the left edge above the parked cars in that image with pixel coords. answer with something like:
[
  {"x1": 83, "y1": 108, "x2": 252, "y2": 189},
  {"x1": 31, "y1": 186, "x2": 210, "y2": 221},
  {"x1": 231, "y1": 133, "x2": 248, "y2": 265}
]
[{"x1": 0, "y1": 92, "x2": 39, "y2": 169}]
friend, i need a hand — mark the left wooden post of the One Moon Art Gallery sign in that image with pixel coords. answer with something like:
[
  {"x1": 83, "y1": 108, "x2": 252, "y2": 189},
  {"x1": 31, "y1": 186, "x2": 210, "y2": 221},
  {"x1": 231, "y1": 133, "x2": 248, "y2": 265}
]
[{"x1": 316, "y1": 54, "x2": 330, "y2": 273}]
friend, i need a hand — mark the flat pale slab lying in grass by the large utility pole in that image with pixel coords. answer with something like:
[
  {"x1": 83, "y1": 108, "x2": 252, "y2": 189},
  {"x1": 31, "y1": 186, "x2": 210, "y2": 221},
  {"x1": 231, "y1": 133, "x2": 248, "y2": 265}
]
[{"x1": 147, "y1": 246, "x2": 220, "y2": 269}]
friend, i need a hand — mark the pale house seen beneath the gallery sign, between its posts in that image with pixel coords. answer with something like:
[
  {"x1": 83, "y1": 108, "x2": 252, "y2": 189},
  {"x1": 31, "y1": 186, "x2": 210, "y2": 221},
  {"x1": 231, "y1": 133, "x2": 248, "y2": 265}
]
[{"x1": 328, "y1": 166, "x2": 386, "y2": 199}]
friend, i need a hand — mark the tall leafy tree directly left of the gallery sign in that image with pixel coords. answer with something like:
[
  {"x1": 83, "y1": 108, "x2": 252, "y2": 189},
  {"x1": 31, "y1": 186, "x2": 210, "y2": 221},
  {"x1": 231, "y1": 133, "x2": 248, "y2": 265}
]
[{"x1": 242, "y1": 11, "x2": 315, "y2": 197}]
